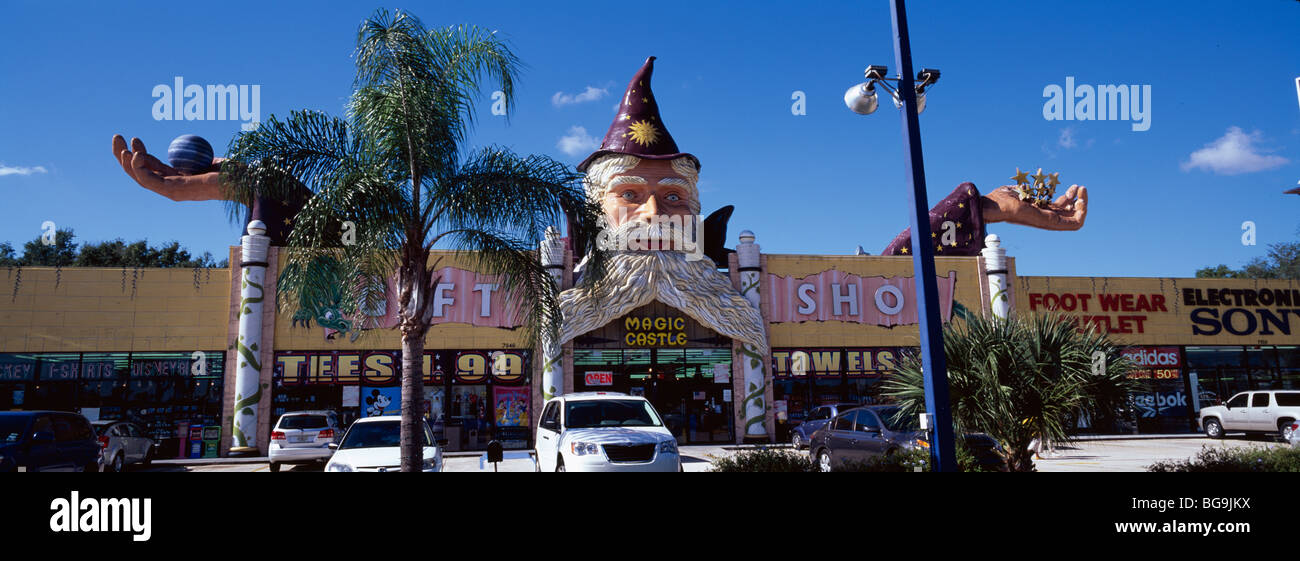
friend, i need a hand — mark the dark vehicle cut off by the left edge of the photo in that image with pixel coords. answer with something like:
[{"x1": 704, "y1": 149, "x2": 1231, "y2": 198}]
[{"x1": 0, "y1": 412, "x2": 100, "y2": 471}]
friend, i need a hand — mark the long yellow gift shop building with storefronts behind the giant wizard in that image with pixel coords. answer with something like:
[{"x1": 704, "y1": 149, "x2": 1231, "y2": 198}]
[{"x1": 0, "y1": 241, "x2": 1300, "y2": 456}]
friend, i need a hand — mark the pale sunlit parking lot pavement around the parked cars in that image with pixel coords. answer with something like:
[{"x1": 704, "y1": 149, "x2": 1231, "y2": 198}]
[{"x1": 127, "y1": 435, "x2": 1283, "y2": 473}]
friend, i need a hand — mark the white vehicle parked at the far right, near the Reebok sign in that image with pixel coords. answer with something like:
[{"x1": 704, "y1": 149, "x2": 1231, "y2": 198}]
[{"x1": 1200, "y1": 390, "x2": 1300, "y2": 440}]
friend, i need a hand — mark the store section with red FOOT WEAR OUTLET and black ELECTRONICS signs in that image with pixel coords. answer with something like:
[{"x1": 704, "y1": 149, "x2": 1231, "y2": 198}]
[{"x1": 1017, "y1": 277, "x2": 1300, "y2": 432}]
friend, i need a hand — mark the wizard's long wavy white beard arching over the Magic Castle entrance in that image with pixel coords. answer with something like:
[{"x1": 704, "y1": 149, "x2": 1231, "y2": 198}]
[{"x1": 559, "y1": 251, "x2": 767, "y2": 355}]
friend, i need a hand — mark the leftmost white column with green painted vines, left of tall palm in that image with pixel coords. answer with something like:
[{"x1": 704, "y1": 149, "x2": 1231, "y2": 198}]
[{"x1": 230, "y1": 221, "x2": 270, "y2": 455}]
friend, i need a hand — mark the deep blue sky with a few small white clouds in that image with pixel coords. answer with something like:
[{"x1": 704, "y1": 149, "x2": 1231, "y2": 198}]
[{"x1": 0, "y1": 0, "x2": 1300, "y2": 277}]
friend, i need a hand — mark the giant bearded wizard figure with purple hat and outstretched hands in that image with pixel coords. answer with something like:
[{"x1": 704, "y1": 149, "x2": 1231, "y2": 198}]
[{"x1": 112, "y1": 57, "x2": 1088, "y2": 444}]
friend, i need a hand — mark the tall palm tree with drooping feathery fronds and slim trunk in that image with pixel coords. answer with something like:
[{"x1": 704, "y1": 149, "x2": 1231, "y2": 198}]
[{"x1": 222, "y1": 10, "x2": 599, "y2": 471}]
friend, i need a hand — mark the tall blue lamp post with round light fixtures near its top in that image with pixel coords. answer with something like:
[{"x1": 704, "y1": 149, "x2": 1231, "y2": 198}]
[{"x1": 844, "y1": 0, "x2": 957, "y2": 471}]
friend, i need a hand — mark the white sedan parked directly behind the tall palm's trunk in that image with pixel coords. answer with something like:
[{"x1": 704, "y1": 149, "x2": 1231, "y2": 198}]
[{"x1": 325, "y1": 417, "x2": 442, "y2": 471}]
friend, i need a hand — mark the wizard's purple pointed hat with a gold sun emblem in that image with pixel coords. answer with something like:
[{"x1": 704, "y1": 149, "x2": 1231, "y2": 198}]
[{"x1": 577, "y1": 57, "x2": 699, "y2": 171}]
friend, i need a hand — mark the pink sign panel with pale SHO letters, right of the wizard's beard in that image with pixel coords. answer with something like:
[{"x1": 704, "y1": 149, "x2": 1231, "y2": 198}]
[{"x1": 767, "y1": 270, "x2": 957, "y2": 327}]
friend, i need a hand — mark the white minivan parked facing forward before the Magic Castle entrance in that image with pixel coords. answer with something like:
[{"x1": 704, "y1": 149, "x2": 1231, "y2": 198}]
[{"x1": 534, "y1": 392, "x2": 681, "y2": 471}]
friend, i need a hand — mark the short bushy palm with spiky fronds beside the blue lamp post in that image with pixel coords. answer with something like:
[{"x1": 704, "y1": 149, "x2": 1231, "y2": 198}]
[{"x1": 884, "y1": 314, "x2": 1135, "y2": 471}]
